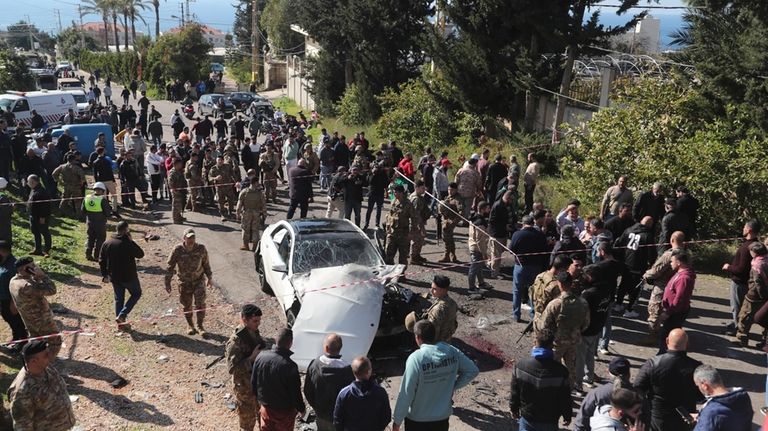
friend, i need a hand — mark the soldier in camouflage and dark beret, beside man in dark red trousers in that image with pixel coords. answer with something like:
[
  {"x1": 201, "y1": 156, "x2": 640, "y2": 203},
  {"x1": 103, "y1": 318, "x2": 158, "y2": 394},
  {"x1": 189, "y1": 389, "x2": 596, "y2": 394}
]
[{"x1": 225, "y1": 304, "x2": 267, "y2": 431}]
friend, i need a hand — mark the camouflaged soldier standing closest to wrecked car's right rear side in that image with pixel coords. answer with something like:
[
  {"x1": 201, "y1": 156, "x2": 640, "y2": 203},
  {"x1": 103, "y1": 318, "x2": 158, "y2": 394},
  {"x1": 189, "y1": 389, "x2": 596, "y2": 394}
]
[{"x1": 384, "y1": 185, "x2": 419, "y2": 265}]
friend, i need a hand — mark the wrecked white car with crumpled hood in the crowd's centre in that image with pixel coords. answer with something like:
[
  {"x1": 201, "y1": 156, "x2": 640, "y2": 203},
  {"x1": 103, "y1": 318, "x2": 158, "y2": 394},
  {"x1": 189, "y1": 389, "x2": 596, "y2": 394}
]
[{"x1": 255, "y1": 219, "x2": 414, "y2": 370}]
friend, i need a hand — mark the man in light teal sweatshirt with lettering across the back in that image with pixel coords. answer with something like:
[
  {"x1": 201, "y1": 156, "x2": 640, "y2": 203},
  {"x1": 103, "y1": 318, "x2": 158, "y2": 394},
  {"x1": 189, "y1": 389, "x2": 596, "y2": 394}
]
[{"x1": 392, "y1": 320, "x2": 480, "y2": 431}]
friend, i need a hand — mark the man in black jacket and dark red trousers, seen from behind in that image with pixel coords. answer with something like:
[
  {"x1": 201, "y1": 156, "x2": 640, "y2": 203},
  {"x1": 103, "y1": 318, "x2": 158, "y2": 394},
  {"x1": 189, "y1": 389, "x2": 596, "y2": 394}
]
[{"x1": 251, "y1": 328, "x2": 305, "y2": 430}]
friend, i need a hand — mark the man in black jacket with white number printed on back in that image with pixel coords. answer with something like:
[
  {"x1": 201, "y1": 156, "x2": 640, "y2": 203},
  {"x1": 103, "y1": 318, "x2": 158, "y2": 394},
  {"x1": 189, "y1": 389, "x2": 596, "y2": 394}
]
[{"x1": 614, "y1": 216, "x2": 653, "y2": 319}]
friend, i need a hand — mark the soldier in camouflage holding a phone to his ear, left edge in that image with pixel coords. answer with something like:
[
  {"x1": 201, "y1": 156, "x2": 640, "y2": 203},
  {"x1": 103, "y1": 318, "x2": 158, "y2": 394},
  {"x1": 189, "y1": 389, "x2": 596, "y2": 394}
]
[{"x1": 10, "y1": 257, "x2": 61, "y2": 358}]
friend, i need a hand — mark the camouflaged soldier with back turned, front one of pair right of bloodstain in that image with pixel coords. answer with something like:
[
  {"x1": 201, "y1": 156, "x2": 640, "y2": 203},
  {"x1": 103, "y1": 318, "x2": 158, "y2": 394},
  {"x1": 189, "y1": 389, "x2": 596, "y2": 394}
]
[{"x1": 534, "y1": 271, "x2": 589, "y2": 389}]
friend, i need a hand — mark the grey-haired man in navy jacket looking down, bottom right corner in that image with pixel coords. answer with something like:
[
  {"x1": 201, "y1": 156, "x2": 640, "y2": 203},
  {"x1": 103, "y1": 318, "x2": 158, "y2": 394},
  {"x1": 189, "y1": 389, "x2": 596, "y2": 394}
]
[{"x1": 693, "y1": 364, "x2": 753, "y2": 431}]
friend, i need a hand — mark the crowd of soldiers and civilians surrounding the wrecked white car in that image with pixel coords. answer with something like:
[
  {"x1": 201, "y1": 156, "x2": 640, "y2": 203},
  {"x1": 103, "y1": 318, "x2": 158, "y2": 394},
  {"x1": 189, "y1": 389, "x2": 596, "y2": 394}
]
[{"x1": 0, "y1": 71, "x2": 768, "y2": 431}]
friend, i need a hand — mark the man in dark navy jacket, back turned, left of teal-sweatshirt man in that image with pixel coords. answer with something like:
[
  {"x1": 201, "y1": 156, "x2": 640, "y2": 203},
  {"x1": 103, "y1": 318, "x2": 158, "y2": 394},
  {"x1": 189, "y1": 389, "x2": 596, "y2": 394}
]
[{"x1": 333, "y1": 356, "x2": 392, "y2": 431}]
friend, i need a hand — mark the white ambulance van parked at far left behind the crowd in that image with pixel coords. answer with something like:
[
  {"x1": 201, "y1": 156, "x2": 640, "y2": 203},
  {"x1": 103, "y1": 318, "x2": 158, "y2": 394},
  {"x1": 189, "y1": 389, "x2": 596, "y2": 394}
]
[{"x1": 0, "y1": 90, "x2": 77, "y2": 127}]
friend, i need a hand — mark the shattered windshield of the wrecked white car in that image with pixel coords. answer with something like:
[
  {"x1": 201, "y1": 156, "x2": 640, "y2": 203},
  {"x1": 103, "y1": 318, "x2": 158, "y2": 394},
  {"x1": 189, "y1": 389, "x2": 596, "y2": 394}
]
[{"x1": 293, "y1": 235, "x2": 384, "y2": 274}]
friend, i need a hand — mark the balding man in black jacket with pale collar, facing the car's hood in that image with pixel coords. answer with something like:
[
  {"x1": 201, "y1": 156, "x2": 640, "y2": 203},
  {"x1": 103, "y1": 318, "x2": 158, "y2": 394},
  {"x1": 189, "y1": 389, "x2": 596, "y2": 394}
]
[{"x1": 304, "y1": 334, "x2": 355, "y2": 431}]
